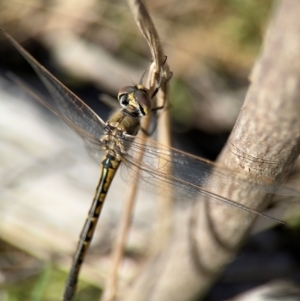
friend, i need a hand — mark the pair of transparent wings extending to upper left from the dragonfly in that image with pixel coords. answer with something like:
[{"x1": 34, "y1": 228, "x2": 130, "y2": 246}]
[{"x1": 0, "y1": 29, "x2": 139, "y2": 162}]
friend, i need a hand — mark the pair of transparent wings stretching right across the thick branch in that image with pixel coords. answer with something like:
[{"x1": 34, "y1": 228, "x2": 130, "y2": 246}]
[{"x1": 123, "y1": 137, "x2": 300, "y2": 219}]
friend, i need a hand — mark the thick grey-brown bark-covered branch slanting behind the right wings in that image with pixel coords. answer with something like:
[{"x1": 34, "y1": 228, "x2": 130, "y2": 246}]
[{"x1": 126, "y1": 0, "x2": 300, "y2": 301}]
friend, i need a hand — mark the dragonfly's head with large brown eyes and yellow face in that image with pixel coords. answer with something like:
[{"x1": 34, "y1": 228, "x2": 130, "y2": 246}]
[{"x1": 118, "y1": 84, "x2": 151, "y2": 117}]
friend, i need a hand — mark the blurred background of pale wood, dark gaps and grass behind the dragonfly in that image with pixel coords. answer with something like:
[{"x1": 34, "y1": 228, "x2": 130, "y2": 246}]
[{"x1": 0, "y1": 0, "x2": 300, "y2": 301}]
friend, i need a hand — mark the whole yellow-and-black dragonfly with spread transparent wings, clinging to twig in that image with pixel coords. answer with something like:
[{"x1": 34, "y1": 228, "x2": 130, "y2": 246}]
[{"x1": 0, "y1": 29, "x2": 291, "y2": 301}]
